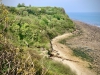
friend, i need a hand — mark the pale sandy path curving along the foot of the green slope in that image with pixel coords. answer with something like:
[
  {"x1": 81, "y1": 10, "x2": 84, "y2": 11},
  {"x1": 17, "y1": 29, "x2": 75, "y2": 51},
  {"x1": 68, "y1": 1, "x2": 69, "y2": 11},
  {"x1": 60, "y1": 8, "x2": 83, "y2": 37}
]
[{"x1": 52, "y1": 33, "x2": 96, "y2": 75}]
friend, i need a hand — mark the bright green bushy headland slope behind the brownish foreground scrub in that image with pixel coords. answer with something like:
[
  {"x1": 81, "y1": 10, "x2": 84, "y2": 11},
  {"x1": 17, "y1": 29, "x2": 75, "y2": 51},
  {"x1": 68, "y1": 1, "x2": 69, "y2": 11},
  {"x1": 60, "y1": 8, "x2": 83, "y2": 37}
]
[{"x1": 7, "y1": 7, "x2": 74, "y2": 47}]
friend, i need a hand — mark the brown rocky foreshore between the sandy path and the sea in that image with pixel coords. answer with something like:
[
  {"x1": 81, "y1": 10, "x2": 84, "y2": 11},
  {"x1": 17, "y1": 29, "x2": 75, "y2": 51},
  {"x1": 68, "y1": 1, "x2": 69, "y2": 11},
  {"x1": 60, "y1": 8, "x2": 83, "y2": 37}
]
[{"x1": 66, "y1": 20, "x2": 100, "y2": 74}]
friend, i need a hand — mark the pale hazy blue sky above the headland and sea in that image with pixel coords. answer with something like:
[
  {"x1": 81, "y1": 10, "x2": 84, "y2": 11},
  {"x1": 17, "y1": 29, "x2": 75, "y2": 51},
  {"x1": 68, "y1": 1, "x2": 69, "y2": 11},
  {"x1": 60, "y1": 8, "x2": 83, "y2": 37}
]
[{"x1": 2, "y1": 0, "x2": 100, "y2": 12}]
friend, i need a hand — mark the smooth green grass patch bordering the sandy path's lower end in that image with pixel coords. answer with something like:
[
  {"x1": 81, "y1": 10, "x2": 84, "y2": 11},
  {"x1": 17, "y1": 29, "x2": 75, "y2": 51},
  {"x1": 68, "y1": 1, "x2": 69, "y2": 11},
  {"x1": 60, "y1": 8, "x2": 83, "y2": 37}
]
[{"x1": 45, "y1": 59, "x2": 76, "y2": 75}]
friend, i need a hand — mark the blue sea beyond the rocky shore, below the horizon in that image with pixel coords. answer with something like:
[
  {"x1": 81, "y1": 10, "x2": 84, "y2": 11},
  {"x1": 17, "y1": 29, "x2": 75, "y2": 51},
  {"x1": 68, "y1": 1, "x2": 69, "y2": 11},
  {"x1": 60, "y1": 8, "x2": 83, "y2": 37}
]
[{"x1": 67, "y1": 12, "x2": 100, "y2": 27}]
